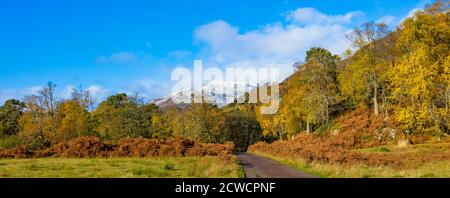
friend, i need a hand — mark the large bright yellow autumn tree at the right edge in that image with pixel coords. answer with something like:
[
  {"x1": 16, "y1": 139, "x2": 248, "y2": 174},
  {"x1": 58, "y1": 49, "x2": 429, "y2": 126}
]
[{"x1": 391, "y1": 2, "x2": 450, "y2": 133}]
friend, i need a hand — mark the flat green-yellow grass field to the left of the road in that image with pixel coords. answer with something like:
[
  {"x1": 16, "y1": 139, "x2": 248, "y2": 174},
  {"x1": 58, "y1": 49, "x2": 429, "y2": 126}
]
[{"x1": 0, "y1": 157, "x2": 243, "y2": 178}]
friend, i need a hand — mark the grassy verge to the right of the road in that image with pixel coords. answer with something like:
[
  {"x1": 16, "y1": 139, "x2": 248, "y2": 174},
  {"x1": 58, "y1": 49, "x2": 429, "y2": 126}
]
[{"x1": 251, "y1": 151, "x2": 450, "y2": 178}]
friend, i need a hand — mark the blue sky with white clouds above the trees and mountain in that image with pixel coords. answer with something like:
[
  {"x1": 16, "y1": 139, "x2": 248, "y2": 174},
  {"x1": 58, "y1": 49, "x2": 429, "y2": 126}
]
[{"x1": 0, "y1": 0, "x2": 427, "y2": 102}]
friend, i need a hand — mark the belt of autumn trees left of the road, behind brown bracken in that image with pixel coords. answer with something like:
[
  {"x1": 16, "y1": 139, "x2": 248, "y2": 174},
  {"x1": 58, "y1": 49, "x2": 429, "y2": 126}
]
[{"x1": 0, "y1": 82, "x2": 262, "y2": 150}]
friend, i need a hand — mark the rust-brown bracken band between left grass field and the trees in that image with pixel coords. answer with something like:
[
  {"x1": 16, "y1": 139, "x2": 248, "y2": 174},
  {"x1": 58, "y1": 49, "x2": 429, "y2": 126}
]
[{"x1": 0, "y1": 137, "x2": 234, "y2": 159}]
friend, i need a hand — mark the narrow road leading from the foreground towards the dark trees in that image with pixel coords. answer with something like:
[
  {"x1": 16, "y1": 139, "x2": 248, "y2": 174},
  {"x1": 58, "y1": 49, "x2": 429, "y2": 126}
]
[{"x1": 237, "y1": 153, "x2": 316, "y2": 178}]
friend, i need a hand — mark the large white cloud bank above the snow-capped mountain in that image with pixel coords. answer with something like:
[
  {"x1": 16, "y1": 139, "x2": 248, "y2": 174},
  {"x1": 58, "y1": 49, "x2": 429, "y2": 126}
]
[{"x1": 194, "y1": 8, "x2": 358, "y2": 81}]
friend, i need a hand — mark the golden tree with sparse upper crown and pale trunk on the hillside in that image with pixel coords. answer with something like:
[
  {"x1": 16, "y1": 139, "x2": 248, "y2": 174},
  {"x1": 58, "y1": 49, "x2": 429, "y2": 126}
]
[{"x1": 339, "y1": 23, "x2": 389, "y2": 115}]
